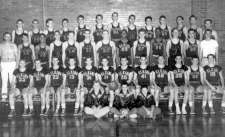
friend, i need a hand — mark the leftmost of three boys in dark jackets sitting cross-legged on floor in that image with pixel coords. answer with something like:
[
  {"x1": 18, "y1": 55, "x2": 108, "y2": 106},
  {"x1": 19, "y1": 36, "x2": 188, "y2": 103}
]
[{"x1": 84, "y1": 81, "x2": 112, "y2": 118}]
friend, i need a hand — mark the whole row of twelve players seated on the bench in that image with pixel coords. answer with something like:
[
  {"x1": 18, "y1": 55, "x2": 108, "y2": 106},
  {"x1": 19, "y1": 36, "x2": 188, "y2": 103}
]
[{"x1": 6, "y1": 55, "x2": 225, "y2": 116}]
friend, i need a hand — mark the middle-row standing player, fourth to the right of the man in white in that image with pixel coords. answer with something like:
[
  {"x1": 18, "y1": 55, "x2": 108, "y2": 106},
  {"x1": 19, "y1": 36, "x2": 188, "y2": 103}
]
[{"x1": 62, "y1": 31, "x2": 80, "y2": 68}]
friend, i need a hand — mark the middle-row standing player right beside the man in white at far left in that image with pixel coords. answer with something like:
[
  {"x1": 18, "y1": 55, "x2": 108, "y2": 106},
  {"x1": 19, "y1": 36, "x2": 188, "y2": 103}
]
[{"x1": 18, "y1": 33, "x2": 35, "y2": 71}]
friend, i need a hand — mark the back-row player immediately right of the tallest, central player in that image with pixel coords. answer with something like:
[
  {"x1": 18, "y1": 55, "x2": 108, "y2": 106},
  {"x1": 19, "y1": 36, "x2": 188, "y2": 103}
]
[{"x1": 126, "y1": 14, "x2": 138, "y2": 47}]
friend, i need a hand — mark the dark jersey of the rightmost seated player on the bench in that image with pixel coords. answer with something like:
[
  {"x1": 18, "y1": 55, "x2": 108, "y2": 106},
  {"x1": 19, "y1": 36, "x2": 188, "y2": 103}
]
[{"x1": 204, "y1": 65, "x2": 222, "y2": 86}]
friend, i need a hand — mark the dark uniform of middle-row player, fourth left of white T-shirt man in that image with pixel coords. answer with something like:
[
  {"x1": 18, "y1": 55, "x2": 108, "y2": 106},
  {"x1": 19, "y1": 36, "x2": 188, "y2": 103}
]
[{"x1": 134, "y1": 41, "x2": 147, "y2": 66}]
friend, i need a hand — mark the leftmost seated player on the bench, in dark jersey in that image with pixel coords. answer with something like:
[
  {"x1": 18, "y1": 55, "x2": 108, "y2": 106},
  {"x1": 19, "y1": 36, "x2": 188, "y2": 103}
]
[{"x1": 8, "y1": 60, "x2": 33, "y2": 117}]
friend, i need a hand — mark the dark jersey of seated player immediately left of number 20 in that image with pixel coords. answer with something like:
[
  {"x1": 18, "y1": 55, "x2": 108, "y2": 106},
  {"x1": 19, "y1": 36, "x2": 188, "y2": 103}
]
[{"x1": 98, "y1": 67, "x2": 114, "y2": 83}]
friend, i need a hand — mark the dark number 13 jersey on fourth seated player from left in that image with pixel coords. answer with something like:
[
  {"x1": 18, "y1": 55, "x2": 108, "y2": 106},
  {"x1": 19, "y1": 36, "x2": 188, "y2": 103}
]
[{"x1": 64, "y1": 67, "x2": 81, "y2": 89}]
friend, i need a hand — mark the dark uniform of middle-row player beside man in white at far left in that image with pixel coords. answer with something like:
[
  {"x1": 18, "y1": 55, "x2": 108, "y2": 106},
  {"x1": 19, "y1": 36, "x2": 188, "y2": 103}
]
[{"x1": 20, "y1": 45, "x2": 33, "y2": 71}]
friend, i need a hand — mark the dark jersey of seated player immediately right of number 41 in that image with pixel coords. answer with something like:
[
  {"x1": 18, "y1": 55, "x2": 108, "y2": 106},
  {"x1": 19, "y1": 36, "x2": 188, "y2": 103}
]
[{"x1": 153, "y1": 65, "x2": 170, "y2": 88}]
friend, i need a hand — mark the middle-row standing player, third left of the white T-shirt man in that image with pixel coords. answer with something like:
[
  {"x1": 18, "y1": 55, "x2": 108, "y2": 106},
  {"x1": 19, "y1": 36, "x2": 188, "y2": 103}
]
[{"x1": 150, "y1": 28, "x2": 167, "y2": 66}]
